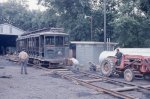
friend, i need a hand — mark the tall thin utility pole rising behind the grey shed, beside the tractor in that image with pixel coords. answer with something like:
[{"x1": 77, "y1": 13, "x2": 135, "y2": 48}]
[{"x1": 104, "y1": 0, "x2": 106, "y2": 50}]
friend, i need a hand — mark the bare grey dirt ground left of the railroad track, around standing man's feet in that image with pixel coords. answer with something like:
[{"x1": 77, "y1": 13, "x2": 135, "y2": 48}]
[{"x1": 0, "y1": 57, "x2": 114, "y2": 99}]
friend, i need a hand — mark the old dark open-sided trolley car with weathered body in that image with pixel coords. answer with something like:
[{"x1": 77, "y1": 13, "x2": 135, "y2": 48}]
[{"x1": 17, "y1": 28, "x2": 69, "y2": 68}]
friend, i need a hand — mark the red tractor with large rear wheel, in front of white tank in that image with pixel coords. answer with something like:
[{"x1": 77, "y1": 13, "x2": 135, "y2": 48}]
[{"x1": 101, "y1": 54, "x2": 150, "y2": 81}]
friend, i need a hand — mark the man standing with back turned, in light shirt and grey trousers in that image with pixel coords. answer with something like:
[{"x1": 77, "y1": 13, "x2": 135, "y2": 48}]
[{"x1": 19, "y1": 49, "x2": 29, "y2": 74}]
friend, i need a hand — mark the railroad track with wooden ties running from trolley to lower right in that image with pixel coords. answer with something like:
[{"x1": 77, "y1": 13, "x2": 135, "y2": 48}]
[{"x1": 32, "y1": 67, "x2": 150, "y2": 99}]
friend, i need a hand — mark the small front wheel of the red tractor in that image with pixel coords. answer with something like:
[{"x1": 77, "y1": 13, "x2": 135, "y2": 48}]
[{"x1": 124, "y1": 69, "x2": 135, "y2": 82}]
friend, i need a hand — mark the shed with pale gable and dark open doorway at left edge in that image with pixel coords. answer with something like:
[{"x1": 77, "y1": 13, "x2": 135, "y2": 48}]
[{"x1": 0, "y1": 23, "x2": 25, "y2": 55}]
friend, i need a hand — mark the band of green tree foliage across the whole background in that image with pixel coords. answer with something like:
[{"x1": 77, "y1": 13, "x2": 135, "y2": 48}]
[{"x1": 0, "y1": 0, "x2": 150, "y2": 47}]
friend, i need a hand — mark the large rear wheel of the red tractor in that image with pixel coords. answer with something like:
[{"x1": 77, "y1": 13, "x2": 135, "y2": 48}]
[{"x1": 100, "y1": 58, "x2": 115, "y2": 77}]
